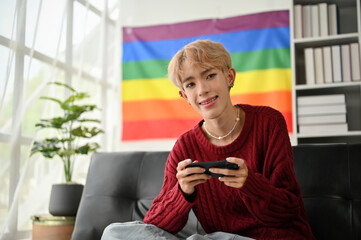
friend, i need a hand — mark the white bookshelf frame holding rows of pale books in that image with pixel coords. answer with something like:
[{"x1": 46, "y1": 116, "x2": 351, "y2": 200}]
[{"x1": 290, "y1": 0, "x2": 361, "y2": 144}]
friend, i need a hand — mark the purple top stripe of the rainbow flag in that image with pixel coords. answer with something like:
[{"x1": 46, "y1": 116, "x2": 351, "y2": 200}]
[{"x1": 123, "y1": 10, "x2": 289, "y2": 42}]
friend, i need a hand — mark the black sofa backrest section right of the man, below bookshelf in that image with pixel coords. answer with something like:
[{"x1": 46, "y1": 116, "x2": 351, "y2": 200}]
[{"x1": 293, "y1": 144, "x2": 361, "y2": 240}]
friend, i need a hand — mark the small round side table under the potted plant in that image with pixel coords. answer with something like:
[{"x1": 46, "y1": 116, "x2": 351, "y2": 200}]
[{"x1": 31, "y1": 214, "x2": 75, "y2": 240}]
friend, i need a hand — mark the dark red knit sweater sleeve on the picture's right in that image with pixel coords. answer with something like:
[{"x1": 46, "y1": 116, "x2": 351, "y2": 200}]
[{"x1": 239, "y1": 111, "x2": 302, "y2": 226}]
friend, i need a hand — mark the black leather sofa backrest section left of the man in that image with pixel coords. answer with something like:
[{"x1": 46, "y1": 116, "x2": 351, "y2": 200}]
[{"x1": 72, "y1": 152, "x2": 169, "y2": 240}]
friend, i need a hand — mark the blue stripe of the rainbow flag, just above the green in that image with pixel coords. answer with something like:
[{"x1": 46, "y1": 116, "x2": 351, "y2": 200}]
[{"x1": 123, "y1": 27, "x2": 290, "y2": 62}]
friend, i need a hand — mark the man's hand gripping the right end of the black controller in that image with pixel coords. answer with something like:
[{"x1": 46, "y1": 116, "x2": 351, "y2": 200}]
[{"x1": 209, "y1": 157, "x2": 248, "y2": 188}]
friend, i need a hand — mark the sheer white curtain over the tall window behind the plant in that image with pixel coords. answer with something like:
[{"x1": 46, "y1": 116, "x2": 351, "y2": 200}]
[{"x1": 0, "y1": 0, "x2": 121, "y2": 240}]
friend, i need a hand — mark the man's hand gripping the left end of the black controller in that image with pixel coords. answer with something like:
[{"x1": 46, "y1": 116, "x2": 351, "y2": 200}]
[{"x1": 176, "y1": 159, "x2": 211, "y2": 195}]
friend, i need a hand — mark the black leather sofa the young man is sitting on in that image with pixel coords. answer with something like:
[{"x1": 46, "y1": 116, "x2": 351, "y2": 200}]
[{"x1": 72, "y1": 144, "x2": 361, "y2": 240}]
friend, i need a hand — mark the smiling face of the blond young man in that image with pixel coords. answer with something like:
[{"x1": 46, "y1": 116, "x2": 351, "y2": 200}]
[{"x1": 180, "y1": 60, "x2": 234, "y2": 119}]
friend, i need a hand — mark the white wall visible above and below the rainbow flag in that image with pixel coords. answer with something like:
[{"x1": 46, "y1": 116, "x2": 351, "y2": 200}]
[{"x1": 119, "y1": 0, "x2": 292, "y2": 151}]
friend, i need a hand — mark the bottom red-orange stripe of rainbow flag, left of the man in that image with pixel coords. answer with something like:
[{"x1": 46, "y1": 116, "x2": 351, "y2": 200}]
[{"x1": 122, "y1": 119, "x2": 200, "y2": 141}]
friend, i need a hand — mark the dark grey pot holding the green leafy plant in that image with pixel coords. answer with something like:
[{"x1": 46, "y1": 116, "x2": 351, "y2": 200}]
[{"x1": 49, "y1": 183, "x2": 84, "y2": 216}]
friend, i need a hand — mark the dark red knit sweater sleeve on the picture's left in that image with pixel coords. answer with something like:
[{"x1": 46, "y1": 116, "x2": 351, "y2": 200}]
[{"x1": 143, "y1": 150, "x2": 193, "y2": 234}]
